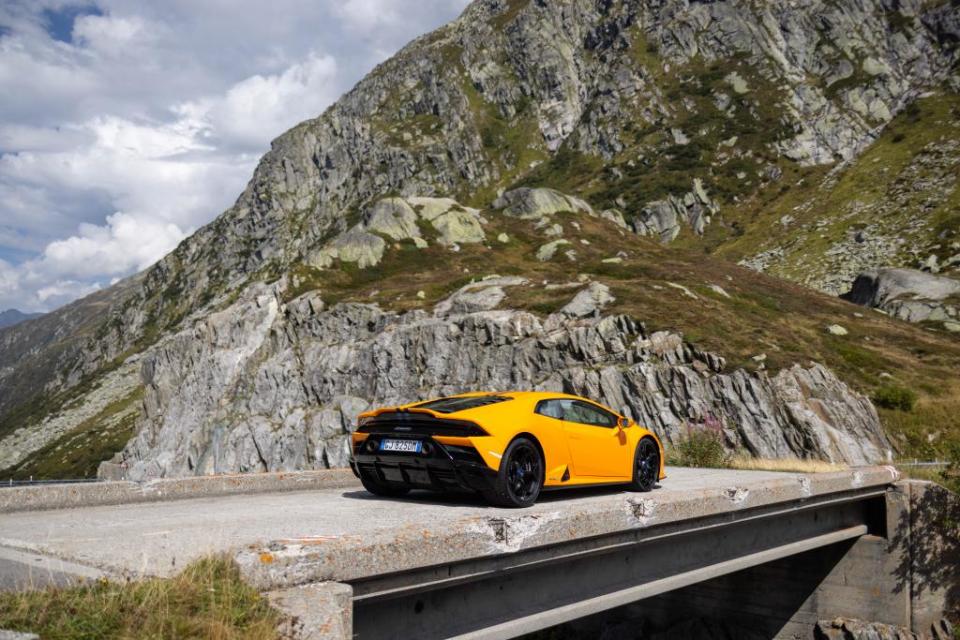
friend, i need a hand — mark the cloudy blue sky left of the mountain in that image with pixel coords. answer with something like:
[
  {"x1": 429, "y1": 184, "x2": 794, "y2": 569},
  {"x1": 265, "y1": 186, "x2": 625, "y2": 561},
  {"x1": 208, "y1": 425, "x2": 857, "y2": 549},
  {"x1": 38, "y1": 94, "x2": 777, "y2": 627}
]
[{"x1": 0, "y1": 0, "x2": 467, "y2": 311}]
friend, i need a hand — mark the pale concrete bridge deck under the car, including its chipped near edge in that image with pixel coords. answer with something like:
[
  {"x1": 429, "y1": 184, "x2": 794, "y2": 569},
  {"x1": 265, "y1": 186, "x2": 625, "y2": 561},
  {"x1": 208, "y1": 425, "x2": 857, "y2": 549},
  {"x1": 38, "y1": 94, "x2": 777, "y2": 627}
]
[{"x1": 0, "y1": 467, "x2": 896, "y2": 590}]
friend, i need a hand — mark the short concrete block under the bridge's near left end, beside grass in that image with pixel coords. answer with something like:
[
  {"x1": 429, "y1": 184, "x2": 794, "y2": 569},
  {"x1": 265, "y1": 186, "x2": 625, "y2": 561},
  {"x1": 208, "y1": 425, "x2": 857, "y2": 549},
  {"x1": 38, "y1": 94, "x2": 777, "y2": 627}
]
[{"x1": 267, "y1": 582, "x2": 353, "y2": 640}]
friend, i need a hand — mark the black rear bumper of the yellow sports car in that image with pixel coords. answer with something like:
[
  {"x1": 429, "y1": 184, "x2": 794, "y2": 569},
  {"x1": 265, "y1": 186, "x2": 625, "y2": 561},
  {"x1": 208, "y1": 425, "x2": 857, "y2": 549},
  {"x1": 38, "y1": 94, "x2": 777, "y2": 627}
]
[{"x1": 350, "y1": 434, "x2": 497, "y2": 491}]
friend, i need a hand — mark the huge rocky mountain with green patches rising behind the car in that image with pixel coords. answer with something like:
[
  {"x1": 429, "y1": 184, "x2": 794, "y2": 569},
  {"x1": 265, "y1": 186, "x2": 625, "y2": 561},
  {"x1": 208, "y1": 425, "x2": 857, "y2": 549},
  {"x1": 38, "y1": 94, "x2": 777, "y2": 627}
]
[{"x1": 0, "y1": 0, "x2": 960, "y2": 477}]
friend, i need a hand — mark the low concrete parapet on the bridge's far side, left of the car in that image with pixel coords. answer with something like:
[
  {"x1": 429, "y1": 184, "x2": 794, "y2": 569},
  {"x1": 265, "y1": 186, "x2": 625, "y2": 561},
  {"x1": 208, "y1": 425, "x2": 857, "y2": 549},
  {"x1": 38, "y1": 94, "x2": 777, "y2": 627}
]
[{"x1": 0, "y1": 469, "x2": 356, "y2": 513}]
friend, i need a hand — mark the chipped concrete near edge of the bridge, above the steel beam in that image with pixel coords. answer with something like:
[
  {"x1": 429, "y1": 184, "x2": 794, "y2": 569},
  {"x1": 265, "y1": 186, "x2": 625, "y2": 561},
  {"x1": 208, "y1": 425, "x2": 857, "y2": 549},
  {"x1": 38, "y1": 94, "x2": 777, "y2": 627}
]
[{"x1": 235, "y1": 467, "x2": 899, "y2": 590}]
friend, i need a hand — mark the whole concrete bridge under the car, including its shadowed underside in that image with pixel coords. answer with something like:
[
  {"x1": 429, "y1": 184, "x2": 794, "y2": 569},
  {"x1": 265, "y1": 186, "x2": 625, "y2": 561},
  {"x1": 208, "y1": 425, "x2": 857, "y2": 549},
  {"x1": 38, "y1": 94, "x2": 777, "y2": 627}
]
[{"x1": 0, "y1": 467, "x2": 958, "y2": 640}]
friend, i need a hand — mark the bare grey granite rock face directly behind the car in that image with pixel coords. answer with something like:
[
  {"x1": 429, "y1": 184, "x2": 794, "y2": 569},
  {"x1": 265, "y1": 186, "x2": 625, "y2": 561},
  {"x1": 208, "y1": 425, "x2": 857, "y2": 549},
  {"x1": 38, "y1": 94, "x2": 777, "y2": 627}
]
[{"x1": 113, "y1": 278, "x2": 888, "y2": 480}]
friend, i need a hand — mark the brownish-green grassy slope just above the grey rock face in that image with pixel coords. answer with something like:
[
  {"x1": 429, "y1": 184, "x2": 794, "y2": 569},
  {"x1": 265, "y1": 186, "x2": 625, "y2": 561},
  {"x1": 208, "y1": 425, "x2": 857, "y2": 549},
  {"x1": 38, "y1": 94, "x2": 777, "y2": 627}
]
[{"x1": 291, "y1": 204, "x2": 960, "y2": 456}]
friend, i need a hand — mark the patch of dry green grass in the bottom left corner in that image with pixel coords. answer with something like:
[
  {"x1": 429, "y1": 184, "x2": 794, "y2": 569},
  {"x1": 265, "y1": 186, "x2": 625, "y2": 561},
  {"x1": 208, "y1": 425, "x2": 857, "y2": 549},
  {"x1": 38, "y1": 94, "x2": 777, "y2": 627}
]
[{"x1": 0, "y1": 557, "x2": 279, "y2": 640}]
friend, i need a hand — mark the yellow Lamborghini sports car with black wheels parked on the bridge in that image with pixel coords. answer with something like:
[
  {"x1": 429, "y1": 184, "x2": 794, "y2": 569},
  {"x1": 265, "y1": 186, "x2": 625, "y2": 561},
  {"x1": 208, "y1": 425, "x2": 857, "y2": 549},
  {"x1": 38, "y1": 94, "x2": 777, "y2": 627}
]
[{"x1": 350, "y1": 391, "x2": 666, "y2": 507}]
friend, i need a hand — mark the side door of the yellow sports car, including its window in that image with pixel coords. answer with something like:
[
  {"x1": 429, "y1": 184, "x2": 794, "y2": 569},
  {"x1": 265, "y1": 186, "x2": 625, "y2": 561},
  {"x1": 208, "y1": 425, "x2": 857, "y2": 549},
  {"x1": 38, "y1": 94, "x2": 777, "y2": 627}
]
[{"x1": 563, "y1": 400, "x2": 634, "y2": 479}]
